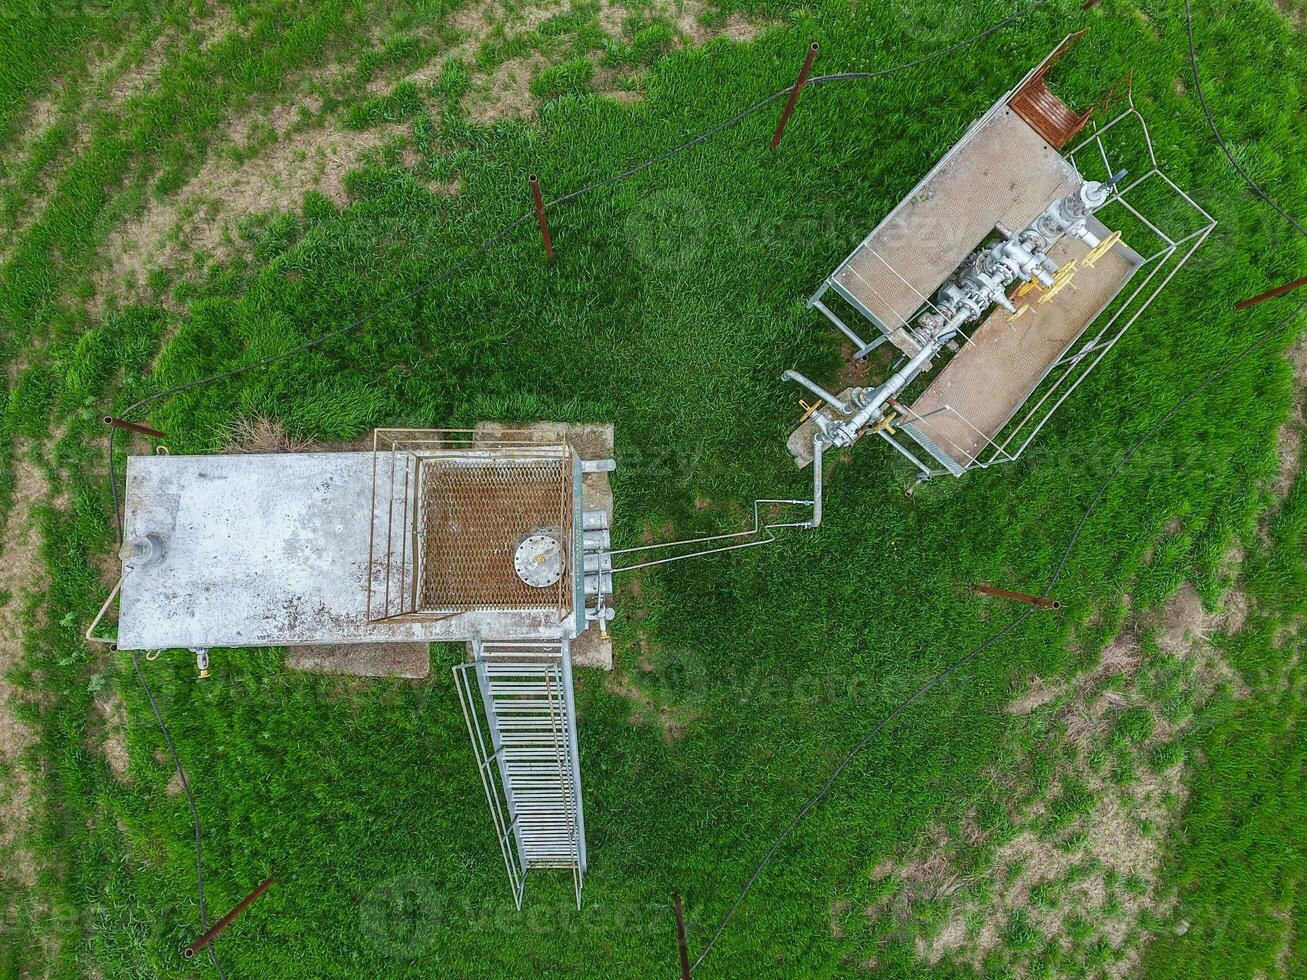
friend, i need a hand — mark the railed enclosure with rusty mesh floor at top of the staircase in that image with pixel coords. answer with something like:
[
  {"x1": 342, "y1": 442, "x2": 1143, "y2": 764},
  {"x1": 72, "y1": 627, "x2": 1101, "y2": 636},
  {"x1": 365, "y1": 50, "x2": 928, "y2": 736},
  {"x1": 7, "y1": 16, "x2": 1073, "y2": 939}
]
[{"x1": 367, "y1": 429, "x2": 580, "y2": 625}]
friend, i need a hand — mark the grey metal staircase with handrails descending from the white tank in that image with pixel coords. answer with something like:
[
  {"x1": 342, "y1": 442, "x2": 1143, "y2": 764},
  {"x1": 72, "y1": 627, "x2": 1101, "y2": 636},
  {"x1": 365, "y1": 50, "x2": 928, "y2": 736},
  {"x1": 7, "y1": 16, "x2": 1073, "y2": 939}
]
[{"x1": 454, "y1": 636, "x2": 586, "y2": 909}]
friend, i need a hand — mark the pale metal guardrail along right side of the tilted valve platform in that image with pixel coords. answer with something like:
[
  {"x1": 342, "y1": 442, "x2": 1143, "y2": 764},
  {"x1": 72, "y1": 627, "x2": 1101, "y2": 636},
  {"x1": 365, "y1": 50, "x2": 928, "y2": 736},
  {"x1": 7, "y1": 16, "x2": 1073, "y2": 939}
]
[{"x1": 877, "y1": 93, "x2": 1217, "y2": 477}]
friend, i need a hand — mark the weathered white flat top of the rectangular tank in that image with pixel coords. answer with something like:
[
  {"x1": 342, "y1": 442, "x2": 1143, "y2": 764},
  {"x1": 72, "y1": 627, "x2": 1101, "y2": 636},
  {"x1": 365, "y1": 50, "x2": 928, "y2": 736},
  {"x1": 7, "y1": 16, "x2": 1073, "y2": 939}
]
[{"x1": 118, "y1": 452, "x2": 559, "y2": 649}]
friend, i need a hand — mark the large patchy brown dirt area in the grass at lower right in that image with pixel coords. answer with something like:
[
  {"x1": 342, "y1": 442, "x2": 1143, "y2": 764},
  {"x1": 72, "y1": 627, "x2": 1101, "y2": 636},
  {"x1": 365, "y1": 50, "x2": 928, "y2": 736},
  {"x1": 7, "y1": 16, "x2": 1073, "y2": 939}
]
[{"x1": 867, "y1": 584, "x2": 1247, "y2": 977}]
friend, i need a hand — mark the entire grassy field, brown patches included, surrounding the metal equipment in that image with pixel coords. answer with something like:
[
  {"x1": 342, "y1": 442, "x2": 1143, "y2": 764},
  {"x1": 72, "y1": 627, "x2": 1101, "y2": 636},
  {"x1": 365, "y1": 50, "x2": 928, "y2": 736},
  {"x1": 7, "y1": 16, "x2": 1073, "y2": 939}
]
[{"x1": 0, "y1": 0, "x2": 1307, "y2": 977}]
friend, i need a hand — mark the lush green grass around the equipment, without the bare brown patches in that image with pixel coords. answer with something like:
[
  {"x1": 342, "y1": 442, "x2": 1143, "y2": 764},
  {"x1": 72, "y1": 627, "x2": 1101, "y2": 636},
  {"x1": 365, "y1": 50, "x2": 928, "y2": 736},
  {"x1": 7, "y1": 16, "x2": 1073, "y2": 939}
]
[{"x1": 0, "y1": 3, "x2": 1307, "y2": 976}]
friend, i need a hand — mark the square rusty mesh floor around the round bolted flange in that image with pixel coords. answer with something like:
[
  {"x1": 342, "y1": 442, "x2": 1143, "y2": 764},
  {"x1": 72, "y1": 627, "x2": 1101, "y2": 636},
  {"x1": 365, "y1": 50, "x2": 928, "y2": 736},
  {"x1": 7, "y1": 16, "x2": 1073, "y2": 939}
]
[{"x1": 418, "y1": 460, "x2": 572, "y2": 614}]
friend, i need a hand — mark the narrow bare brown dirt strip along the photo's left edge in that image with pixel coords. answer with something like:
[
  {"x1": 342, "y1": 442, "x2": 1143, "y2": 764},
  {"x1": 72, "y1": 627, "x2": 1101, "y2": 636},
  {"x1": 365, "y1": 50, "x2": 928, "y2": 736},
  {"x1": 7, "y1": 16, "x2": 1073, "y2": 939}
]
[{"x1": 0, "y1": 443, "x2": 50, "y2": 889}]
